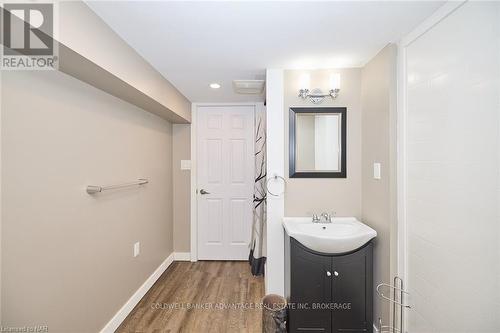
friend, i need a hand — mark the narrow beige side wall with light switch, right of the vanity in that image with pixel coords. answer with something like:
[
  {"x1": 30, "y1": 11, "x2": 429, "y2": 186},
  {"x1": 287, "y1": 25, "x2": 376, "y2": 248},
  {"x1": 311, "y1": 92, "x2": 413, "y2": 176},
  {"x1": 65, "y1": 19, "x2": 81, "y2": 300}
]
[{"x1": 361, "y1": 45, "x2": 397, "y2": 325}]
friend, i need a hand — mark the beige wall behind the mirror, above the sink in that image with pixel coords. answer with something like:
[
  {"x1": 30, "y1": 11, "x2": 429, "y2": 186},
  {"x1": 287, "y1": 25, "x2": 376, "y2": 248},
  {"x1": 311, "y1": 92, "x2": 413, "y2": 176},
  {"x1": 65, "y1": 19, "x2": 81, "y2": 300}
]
[{"x1": 283, "y1": 68, "x2": 361, "y2": 218}]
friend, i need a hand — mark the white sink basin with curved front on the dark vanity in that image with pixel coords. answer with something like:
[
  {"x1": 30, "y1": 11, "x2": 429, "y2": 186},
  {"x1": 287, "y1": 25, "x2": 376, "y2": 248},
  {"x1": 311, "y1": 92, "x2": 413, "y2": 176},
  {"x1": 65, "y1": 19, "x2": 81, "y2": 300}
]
[{"x1": 283, "y1": 217, "x2": 377, "y2": 254}]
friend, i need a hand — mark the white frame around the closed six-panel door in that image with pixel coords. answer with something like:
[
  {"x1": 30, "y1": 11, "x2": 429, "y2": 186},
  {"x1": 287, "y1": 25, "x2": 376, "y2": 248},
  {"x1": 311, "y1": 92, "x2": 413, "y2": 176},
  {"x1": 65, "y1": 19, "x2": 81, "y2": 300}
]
[{"x1": 190, "y1": 102, "x2": 264, "y2": 262}]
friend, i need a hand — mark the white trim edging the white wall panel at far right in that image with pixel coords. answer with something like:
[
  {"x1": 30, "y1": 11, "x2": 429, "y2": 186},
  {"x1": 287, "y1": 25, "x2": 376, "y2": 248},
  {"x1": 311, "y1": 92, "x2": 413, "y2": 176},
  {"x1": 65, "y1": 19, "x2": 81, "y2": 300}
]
[{"x1": 396, "y1": 1, "x2": 467, "y2": 326}]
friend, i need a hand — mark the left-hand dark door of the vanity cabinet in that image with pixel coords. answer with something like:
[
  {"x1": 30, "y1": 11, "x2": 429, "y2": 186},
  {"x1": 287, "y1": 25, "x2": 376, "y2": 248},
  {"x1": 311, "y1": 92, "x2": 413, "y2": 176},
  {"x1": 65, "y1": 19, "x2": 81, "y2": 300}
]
[{"x1": 288, "y1": 238, "x2": 332, "y2": 333}]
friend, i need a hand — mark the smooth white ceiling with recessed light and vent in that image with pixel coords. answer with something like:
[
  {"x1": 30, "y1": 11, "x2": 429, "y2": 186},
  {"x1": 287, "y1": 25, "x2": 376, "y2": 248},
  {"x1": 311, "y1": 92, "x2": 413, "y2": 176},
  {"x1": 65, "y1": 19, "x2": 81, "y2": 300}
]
[{"x1": 87, "y1": 1, "x2": 443, "y2": 102}]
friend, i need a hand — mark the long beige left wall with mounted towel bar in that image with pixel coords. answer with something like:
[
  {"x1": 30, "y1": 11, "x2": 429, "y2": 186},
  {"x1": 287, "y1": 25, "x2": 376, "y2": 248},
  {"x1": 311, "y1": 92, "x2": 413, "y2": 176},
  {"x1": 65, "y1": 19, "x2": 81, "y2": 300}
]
[{"x1": 1, "y1": 71, "x2": 173, "y2": 332}]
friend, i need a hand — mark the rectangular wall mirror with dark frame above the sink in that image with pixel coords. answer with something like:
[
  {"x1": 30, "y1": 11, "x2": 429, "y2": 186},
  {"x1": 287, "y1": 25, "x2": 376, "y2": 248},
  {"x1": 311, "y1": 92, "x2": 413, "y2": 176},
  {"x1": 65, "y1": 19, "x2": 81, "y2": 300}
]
[{"x1": 289, "y1": 107, "x2": 347, "y2": 178}]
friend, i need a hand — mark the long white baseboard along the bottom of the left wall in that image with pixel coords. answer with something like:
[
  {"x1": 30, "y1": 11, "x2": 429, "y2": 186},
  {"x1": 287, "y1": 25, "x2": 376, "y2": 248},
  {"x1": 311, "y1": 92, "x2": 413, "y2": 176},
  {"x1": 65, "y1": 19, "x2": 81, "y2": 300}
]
[{"x1": 101, "y1": 253, "x2": 175, "y2": 333}]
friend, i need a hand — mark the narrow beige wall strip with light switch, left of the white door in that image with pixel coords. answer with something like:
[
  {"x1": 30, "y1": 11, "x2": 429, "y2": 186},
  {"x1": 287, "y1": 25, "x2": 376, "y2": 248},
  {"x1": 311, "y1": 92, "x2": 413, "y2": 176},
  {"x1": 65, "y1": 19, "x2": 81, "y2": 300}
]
[{"x1": 172, "y1": 124, "x2": 191, "y2": 252}]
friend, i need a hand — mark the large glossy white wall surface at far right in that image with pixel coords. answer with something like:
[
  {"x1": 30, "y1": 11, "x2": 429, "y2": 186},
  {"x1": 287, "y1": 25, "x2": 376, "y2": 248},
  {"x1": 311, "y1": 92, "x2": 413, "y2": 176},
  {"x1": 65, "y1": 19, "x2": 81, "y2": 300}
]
[{"x1": 406, "y1": 2, "x2": 500, "y2": 333}]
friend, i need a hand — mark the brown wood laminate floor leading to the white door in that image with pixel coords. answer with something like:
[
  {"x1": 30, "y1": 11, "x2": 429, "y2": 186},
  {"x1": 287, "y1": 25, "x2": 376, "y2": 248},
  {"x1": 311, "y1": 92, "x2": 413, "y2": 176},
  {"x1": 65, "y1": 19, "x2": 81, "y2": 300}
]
[{"x1": 116, "y1": 261, "x2": 264, "y2": 333}]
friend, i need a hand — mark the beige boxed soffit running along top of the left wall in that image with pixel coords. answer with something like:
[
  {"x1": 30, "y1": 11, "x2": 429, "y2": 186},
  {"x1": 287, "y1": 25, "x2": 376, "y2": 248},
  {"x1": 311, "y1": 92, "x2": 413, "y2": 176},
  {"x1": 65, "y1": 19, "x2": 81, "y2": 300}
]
[{"x1": 1, "y1": 1, "x2": 191, "y2": 123}]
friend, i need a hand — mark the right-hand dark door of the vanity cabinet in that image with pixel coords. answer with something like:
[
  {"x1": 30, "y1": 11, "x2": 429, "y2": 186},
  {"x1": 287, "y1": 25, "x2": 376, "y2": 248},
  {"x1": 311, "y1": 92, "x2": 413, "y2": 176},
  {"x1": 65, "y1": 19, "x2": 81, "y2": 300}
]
[{"x1": 332, "y1": 244, "x2": 373, "y2": 333}]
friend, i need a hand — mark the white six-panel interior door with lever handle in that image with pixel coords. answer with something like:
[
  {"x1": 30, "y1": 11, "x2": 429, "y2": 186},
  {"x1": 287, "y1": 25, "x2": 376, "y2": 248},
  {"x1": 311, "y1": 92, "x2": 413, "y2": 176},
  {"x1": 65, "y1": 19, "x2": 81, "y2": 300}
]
[{"x1": 196, "y1": 106, "x2": 255, "y2": 260}]
